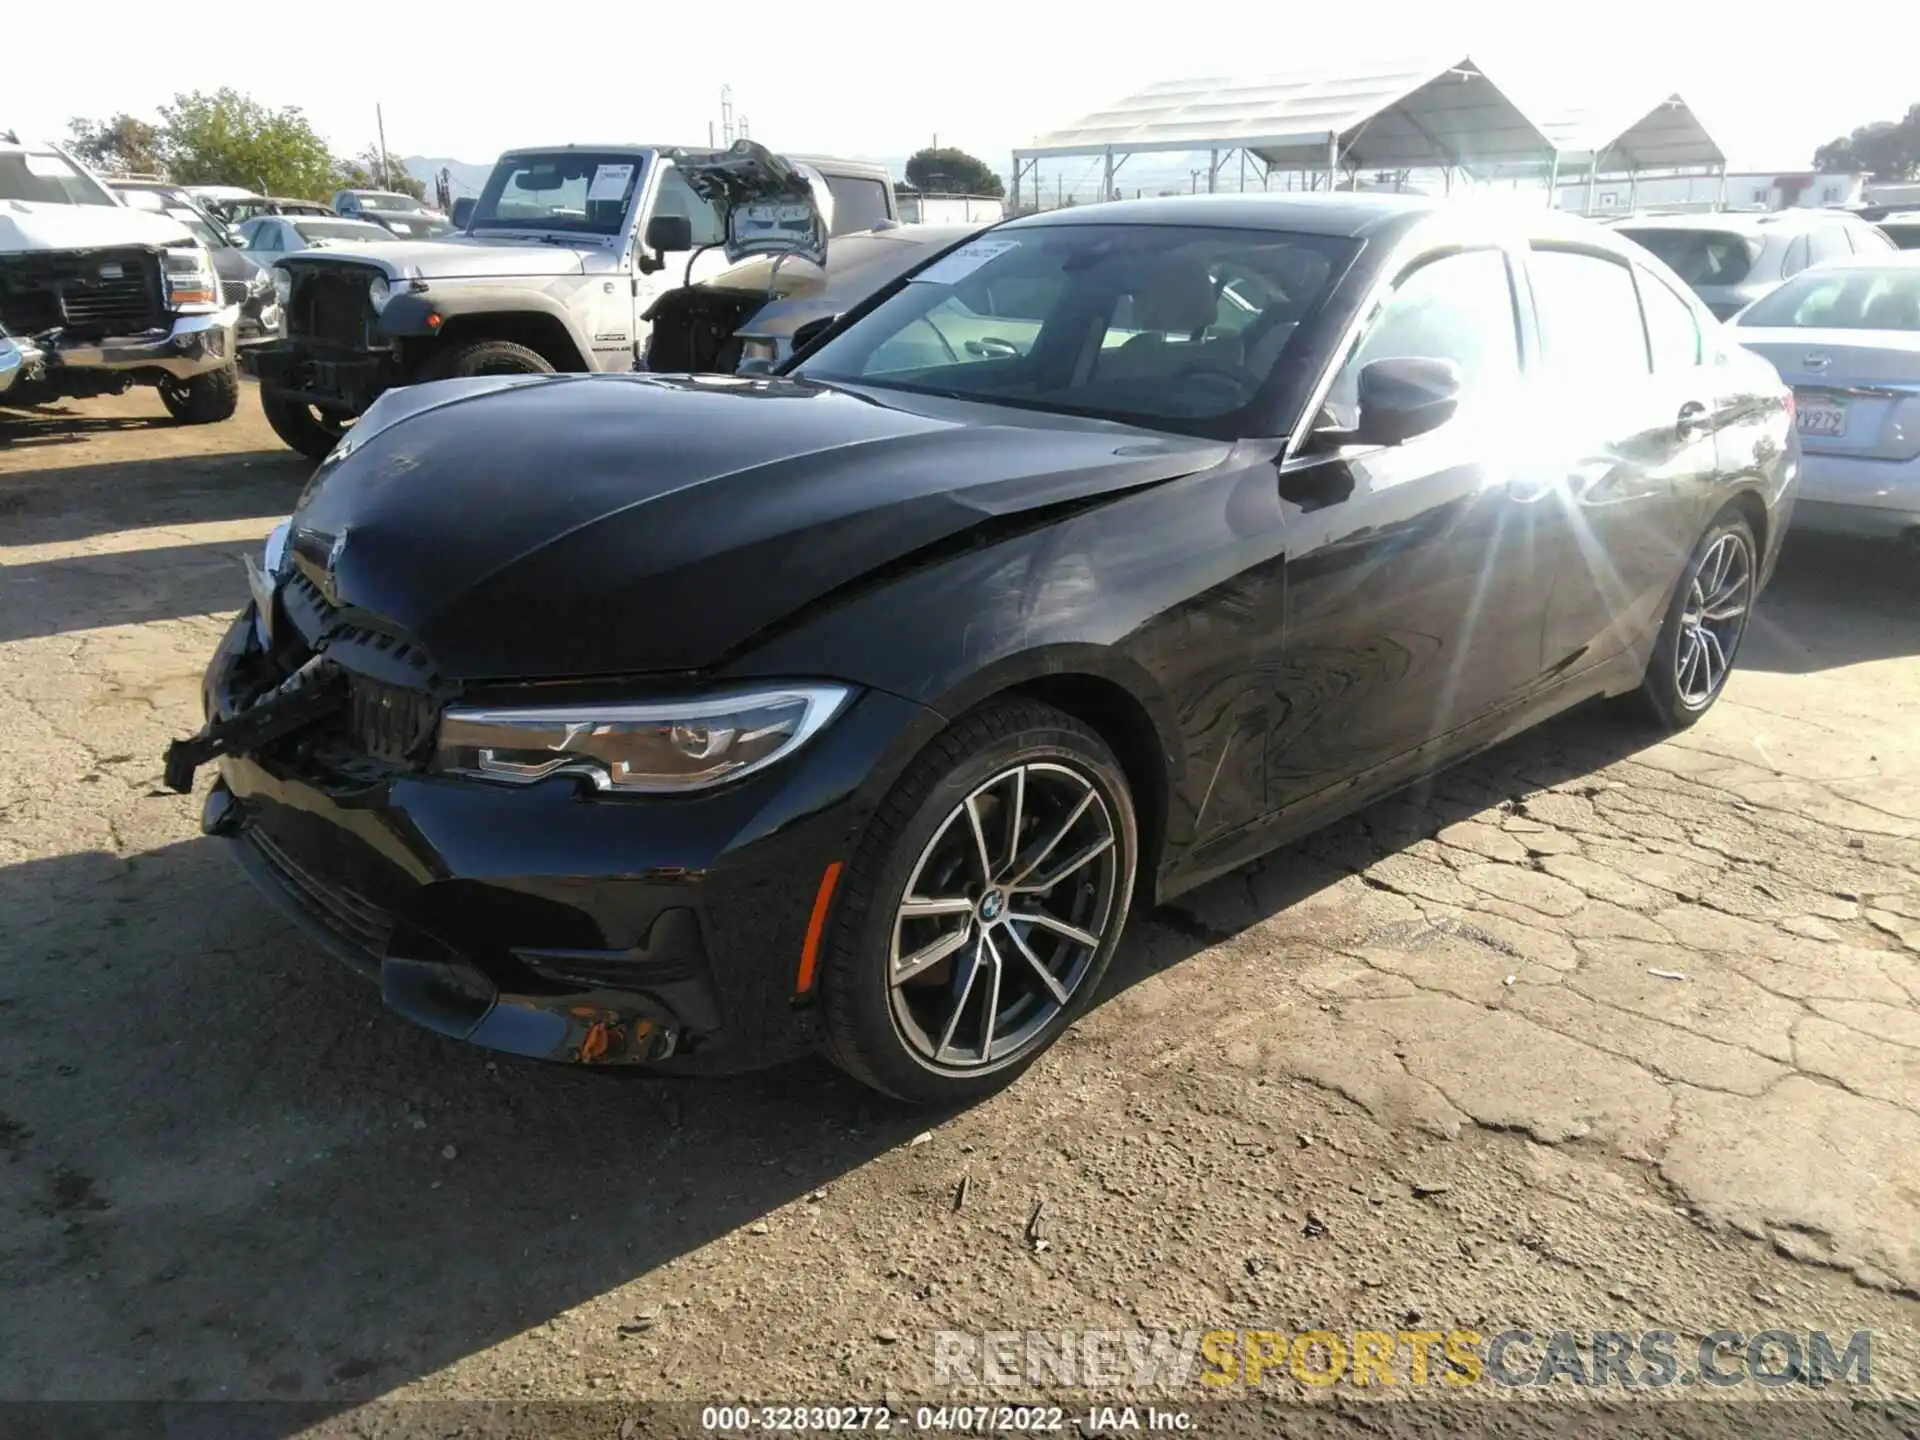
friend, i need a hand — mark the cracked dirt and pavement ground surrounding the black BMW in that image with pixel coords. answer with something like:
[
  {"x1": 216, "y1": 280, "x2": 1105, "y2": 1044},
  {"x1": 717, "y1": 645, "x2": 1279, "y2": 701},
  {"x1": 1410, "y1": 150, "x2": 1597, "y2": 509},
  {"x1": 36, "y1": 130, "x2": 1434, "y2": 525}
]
[{"x1": 0, "y1": 392, "x2": 1920, "y2": 1436}]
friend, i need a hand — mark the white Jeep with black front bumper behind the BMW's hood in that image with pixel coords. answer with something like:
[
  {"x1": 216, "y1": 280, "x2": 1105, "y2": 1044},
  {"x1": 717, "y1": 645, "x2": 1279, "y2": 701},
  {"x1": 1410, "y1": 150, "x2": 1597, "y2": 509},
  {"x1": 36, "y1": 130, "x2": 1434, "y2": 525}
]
[{"x1": 248, "y1": 140, "x2": 883, "y2": 459}]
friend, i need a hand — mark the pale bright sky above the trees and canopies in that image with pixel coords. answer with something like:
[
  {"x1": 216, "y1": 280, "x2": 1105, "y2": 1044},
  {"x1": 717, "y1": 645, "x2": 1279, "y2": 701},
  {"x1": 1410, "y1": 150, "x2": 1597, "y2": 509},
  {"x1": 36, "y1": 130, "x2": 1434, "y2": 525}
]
[{"x1": 0, "y1": 0, "x2": 1920, "y2": 173}]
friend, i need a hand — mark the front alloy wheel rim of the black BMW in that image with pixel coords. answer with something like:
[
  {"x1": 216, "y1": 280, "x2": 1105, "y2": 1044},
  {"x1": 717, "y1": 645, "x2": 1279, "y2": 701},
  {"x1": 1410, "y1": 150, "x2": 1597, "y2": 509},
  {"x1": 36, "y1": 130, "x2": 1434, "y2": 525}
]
[{"x1": 887, "y1": 760, "x2": 1121, "y2": 1071}]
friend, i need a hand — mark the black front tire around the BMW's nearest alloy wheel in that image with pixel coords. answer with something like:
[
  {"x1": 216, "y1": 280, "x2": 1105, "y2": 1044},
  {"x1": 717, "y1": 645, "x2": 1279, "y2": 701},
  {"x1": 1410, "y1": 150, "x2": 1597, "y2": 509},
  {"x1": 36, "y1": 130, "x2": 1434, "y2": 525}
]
[{"x1": 818, "y1": 699, "x2": 1139, "y2": 1104}]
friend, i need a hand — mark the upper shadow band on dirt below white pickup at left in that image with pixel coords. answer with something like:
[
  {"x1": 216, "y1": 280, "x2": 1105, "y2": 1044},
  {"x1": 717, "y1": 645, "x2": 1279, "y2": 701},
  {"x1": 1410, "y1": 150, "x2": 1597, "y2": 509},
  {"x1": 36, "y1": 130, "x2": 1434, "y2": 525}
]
[{"x1": 0, "y1": 445, "x2": 313, "y2": 552}]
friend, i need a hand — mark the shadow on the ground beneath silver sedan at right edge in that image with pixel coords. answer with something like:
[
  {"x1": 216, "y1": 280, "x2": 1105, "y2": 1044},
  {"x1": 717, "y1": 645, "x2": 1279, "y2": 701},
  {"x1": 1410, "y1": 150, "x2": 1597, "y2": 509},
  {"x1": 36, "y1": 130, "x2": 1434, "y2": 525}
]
[{"x1": 1740, "y1": 534, "x2": 1920, "y2": 676}]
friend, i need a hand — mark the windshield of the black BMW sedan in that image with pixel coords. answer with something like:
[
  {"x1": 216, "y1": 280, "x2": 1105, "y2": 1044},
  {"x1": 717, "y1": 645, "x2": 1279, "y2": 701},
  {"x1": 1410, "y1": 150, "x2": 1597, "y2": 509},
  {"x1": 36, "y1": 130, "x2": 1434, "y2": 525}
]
[{"x1": 799, "y1": 225, "x2": 1354, "y2": 432}]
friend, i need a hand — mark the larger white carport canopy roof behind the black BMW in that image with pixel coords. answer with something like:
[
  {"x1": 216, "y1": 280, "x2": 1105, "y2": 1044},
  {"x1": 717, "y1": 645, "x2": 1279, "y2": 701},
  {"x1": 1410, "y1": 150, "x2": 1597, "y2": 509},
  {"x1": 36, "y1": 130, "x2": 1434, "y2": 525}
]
[{"x1": 1014, "y1": 60, "x2": 1553, "y2": 171}]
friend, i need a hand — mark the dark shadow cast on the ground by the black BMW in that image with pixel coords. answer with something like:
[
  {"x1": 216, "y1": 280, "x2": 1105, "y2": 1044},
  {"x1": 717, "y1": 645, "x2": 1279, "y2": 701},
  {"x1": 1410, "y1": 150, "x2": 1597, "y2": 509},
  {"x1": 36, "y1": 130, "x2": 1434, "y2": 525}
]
[{"x1": 0, "y1": 698, "x2": 1653, "y2": 1430}]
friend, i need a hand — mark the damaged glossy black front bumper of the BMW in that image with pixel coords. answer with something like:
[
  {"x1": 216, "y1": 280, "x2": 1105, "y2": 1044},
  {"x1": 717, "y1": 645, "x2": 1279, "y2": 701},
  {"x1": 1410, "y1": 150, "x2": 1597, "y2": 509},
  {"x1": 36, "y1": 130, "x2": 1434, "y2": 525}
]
[{"x1": 185, "y1": 607, "x2": 925, "y2": 1071}]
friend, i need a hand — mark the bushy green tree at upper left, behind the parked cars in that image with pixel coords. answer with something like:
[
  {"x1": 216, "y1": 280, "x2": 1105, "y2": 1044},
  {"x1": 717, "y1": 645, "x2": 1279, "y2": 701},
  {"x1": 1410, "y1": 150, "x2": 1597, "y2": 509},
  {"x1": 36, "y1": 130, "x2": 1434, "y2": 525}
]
[{"x1": 159, "y1": 88, "x2": 334, "y2": 200}]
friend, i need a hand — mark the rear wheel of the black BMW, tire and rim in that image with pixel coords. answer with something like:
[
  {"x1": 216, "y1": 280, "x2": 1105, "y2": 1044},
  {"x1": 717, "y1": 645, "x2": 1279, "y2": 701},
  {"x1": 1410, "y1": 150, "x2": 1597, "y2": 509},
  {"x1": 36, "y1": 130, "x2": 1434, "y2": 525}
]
[{"x1": 1638, "y1": 509, "x2": 1761, "y2": 732}]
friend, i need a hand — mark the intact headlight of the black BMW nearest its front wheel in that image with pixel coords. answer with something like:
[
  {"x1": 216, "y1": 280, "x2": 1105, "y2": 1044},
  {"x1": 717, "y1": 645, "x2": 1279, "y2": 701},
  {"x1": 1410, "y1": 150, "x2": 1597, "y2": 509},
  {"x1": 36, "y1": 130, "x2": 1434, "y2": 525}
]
[{"x1": 434, "y1": 684, "x2": 851, "y2": 795}]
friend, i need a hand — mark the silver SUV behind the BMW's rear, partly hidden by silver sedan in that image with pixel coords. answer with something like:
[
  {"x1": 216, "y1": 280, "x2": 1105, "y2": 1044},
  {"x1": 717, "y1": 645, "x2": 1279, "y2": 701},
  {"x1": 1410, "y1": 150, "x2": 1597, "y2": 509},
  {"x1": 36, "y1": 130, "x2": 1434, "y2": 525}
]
[{"x1": 1613, "y1": 209, "x2": 1893, "y2": 321}]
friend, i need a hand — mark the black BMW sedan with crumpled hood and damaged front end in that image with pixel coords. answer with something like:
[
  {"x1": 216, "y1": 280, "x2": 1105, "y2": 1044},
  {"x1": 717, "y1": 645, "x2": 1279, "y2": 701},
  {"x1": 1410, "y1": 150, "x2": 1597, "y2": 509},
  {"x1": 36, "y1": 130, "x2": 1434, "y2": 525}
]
[{"x1": 169, "y1": 196, "x2": 1799, "y2": 1102}]
